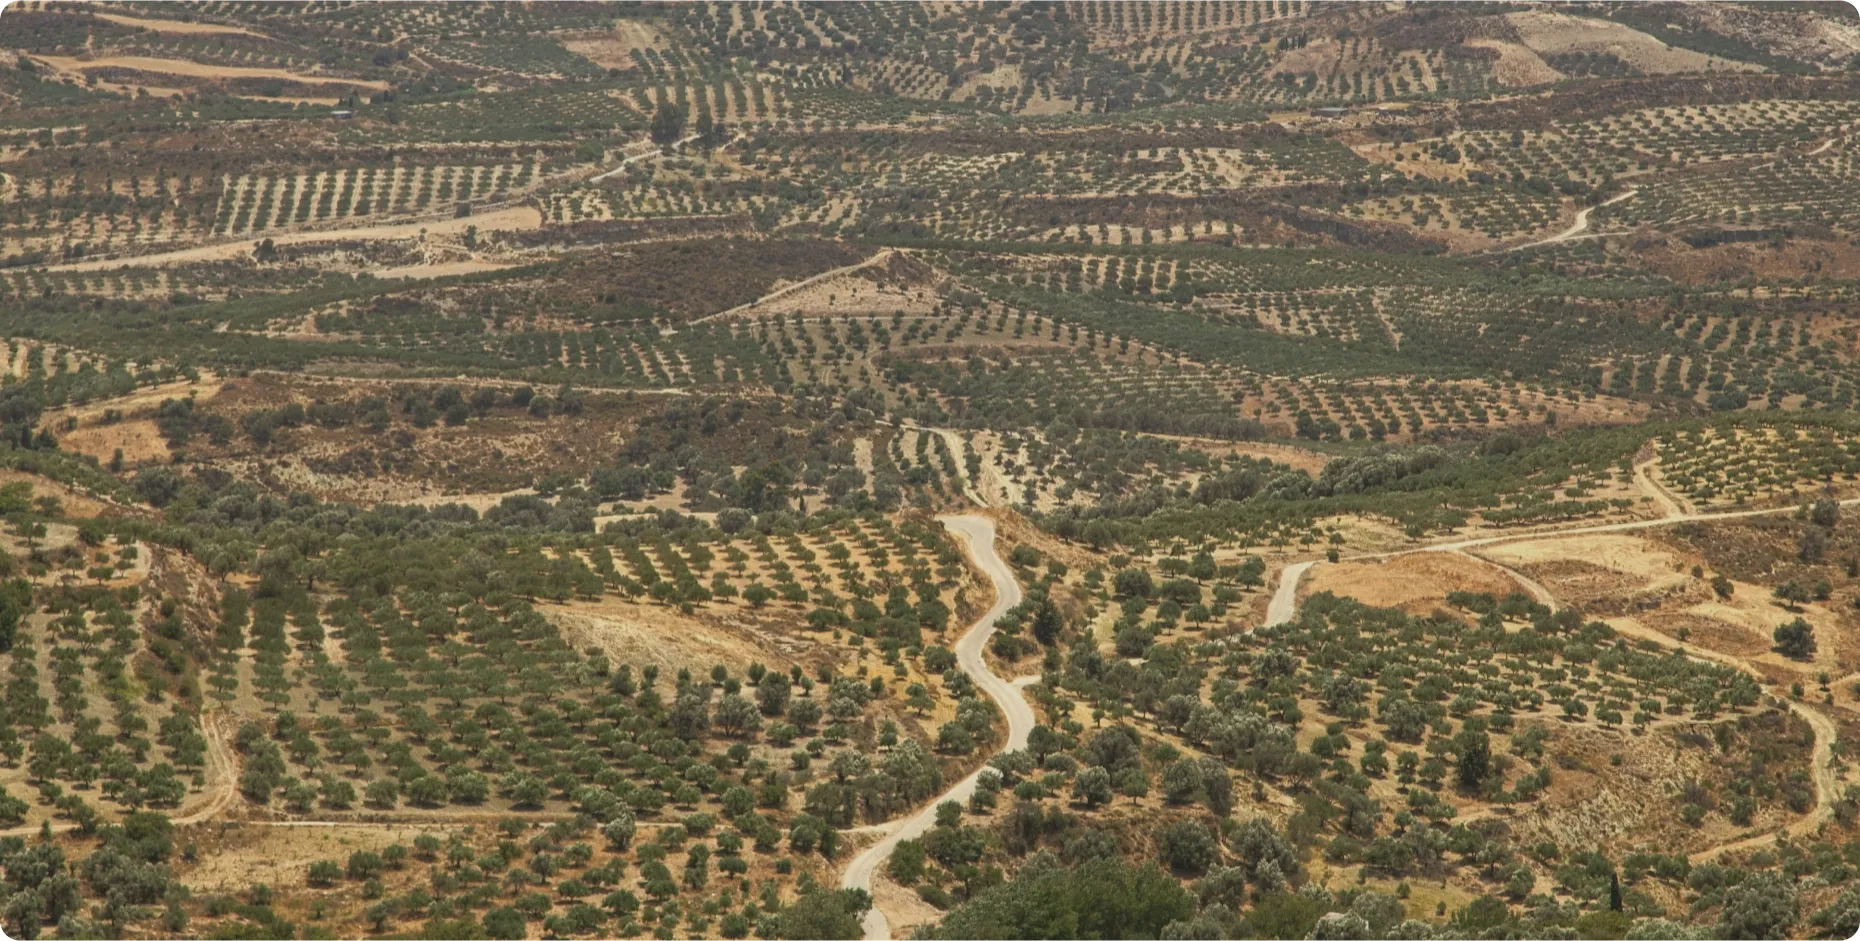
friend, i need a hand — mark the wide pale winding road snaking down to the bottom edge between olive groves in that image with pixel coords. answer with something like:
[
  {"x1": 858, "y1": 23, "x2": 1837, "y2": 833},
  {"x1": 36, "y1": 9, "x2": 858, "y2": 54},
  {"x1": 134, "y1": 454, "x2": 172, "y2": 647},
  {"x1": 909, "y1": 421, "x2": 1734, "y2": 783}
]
[{"x1": 839, "y1": 515, "x2": 1034, "y2": 941}]
